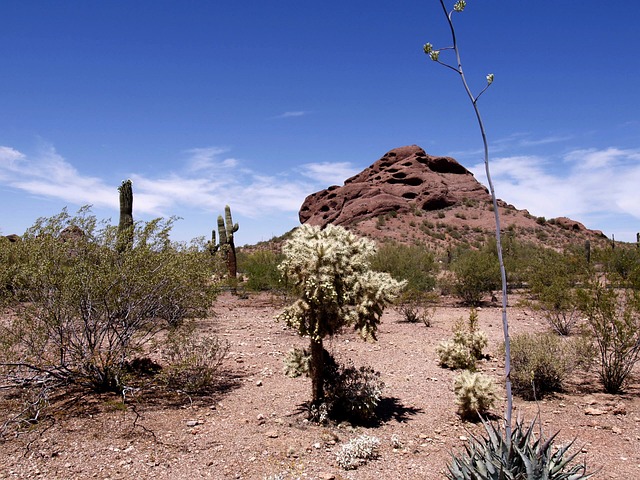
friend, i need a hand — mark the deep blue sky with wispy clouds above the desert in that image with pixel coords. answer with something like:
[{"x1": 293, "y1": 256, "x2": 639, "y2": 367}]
[{"x1": 0, "y1": 0, "x2": 640, "y2": 245}]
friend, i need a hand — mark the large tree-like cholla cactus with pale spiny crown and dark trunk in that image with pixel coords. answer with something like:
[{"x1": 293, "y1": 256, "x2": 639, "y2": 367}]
[{"x1": 278, "y1": 225, "x2": 406, "y2": 404}]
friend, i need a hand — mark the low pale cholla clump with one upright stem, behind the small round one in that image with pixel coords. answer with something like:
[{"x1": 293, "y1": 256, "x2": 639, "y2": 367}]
[{"x1": 436, "y1": 308, "x2": 488, "y2": 370}]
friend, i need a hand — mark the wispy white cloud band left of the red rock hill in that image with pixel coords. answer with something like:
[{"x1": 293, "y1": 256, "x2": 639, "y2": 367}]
[{"x1": 0, "y1": 142, "x2": 324, "y2": 217}]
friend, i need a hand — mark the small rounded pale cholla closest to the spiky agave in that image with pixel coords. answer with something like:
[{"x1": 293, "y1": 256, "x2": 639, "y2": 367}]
[{"x1": 453, "y1": 370, "x2": 497, "y2": 420}]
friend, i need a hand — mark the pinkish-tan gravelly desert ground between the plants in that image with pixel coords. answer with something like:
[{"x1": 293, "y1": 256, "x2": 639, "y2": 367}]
[{"x1": 0, "y1": 294, "x2": 640, "y2": 480}]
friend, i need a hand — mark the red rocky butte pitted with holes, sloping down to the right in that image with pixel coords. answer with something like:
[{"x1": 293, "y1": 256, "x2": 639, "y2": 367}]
[{"x1": 299, "y1": 145, "x2": 606, "y2": 250}]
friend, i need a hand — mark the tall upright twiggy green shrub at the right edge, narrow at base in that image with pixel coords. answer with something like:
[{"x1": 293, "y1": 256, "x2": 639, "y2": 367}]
[{"x1": 578, "y1": 279, "x2": 640, "y2": 393}]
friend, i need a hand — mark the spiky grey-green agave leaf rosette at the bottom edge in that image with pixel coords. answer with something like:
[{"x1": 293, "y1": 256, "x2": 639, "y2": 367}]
[{"x1": 446, "y1": 420, "x2": 594, "y2": 480}]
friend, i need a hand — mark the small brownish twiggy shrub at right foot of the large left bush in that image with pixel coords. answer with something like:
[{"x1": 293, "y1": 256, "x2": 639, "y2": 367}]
[{"x1": 162, "y1": 327, "x2": 229, "y2": 394}]
